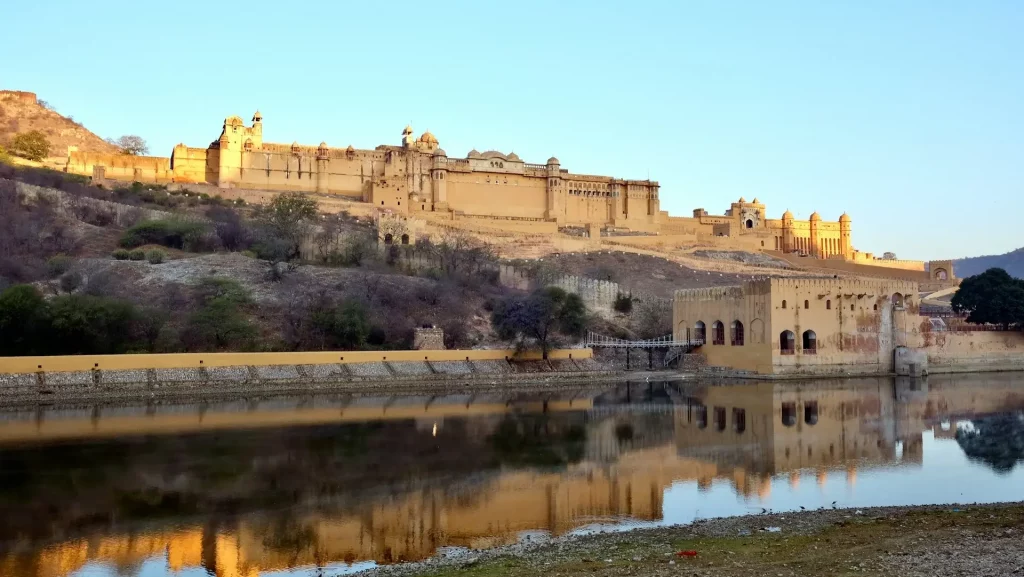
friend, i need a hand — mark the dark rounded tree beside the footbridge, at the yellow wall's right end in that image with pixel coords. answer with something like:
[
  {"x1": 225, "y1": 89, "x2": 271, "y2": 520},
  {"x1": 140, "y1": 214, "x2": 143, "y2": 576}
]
[{"x1": 490, "y1": 287, "x2": 587, "y2": 359}]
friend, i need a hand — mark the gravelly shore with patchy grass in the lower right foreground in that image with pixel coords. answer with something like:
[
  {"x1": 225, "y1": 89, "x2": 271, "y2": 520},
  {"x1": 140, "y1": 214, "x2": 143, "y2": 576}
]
[{"x1": 359, "y1": 503, "x2": 1024, "y2": 577}]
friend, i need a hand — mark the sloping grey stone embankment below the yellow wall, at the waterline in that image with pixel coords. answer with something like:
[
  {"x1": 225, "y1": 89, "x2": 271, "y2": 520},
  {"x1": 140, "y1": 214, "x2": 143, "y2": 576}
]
[{"x1": 0, "y1": 358, "x2": 621, "y2": 405}]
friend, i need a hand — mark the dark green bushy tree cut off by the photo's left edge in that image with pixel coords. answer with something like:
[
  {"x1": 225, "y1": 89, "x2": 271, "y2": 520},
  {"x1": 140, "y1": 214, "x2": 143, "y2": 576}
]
[{"x1": 0, "y1": 285, "x2": 49, "y2": 356}]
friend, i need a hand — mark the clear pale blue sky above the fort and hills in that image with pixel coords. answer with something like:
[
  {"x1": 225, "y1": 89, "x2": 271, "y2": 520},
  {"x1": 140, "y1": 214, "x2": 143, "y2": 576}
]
[{"x1": 0, "y1": 0, "x2": 1024, "y2": 258}]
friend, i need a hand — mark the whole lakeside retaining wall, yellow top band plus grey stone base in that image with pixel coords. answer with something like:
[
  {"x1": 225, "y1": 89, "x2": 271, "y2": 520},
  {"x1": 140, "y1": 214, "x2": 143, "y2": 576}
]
[{"x1": 0, "y1": 348, "x2": 614, "y2": 404}]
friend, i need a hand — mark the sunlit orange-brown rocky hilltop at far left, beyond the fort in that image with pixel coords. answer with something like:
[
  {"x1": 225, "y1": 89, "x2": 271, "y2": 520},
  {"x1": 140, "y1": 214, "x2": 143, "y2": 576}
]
[{"x1": 0, "y1": 90, "x2": 118, "y2": 157}]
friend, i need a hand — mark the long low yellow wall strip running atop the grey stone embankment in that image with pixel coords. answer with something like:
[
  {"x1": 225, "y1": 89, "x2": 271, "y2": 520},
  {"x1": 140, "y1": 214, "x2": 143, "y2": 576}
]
[{"x1": 0, "y1": 348, "x2": 593, "y2": 373}]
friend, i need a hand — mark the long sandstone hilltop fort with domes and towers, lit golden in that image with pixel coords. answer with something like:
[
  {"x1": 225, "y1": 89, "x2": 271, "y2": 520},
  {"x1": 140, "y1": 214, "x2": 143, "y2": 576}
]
[{"x1": 65, "y1": 111, "x2": 929, "y2": 274}]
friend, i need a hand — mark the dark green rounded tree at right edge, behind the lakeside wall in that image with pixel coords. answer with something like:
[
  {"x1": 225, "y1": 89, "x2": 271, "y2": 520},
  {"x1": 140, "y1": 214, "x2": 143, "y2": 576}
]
[{"x1": 951, "y1": 269, "x2": 1024, "y2": 328}]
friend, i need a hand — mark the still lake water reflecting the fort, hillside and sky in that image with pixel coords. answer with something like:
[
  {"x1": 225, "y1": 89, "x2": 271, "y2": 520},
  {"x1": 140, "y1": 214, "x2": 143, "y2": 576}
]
[{"x1": 0, "y1": 375, "x2": 1024, "y2": 577}]
